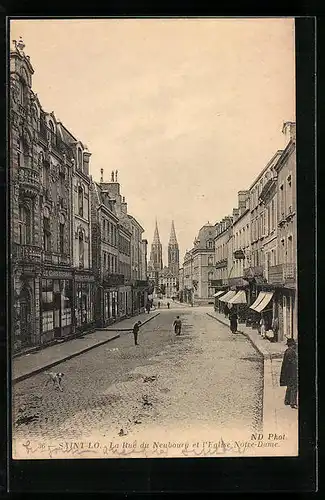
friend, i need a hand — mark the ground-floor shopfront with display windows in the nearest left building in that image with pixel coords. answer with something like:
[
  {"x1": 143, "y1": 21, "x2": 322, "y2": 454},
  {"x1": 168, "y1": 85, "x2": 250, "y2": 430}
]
[{"x1": 12, "y1": 268, "x2": 95, "y2": 352}]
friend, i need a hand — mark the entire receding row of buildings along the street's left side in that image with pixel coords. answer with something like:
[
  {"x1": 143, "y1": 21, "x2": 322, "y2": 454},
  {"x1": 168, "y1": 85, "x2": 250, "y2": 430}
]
[{"x1": 9, "y1": 40, "x2": 150, "y2": 352}]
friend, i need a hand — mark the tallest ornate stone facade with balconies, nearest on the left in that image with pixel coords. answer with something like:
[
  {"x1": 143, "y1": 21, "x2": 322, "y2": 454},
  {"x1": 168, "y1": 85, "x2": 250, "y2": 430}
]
[{"x1": 9, "y1": 40, "x2": 94, "y2": 352}]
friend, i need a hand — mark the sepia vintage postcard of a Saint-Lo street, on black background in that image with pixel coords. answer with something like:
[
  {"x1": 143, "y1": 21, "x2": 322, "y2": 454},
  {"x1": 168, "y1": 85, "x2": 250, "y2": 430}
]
[{"x1": 8, "y1": 18, "x2": 299, "y2": 459}]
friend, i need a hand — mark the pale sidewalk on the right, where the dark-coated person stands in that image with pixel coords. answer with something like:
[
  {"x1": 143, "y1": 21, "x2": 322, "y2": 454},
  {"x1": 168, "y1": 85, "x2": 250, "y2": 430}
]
[{"x1": 207, "y1": 310, "x2": 298, "y2": 453}]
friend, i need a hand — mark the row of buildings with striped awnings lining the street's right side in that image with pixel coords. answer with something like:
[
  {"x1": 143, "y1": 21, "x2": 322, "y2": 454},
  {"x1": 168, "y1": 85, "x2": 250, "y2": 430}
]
[{"x1": 179, "y1": 122, "x2": 297, "y2": 341}]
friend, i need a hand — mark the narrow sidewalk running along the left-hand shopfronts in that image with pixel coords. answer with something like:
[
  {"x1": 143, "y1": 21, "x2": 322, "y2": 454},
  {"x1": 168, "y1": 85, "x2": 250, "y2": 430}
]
[{"x1": 12, "y1": 312, "x2": 159, "y2": 383}]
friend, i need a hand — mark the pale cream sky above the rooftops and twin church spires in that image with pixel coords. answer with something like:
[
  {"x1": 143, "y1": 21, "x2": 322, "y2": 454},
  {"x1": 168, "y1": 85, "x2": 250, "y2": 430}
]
[{"x1": 10, "y1": 18, "x2": 295, "y2": 264}]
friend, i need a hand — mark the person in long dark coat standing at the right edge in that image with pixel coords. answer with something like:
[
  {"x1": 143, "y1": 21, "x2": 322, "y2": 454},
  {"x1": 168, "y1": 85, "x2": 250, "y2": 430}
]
[{"x1": 280, "y1": 339, "x2": 298, "y2": 408}]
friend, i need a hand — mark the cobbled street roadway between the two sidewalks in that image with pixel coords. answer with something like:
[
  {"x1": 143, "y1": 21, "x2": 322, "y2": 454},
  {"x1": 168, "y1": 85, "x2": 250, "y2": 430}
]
[{"x1": 13, "y1": 304, "x2": 263, "y2": 458}]
